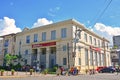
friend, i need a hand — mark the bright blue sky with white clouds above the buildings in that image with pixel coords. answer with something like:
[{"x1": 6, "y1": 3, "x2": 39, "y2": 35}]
[{"x1": 0, "y1": 0, "x2": 120, "y2": 44}]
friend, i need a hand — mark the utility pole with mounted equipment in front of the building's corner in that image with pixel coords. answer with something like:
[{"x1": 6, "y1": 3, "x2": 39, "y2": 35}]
[{"x1": 72, "y1": 27, "x2": 82, "y2": 66}]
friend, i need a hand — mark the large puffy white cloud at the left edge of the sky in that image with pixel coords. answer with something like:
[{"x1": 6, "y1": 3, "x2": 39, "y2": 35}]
[{"x1": 0, "y1": 17, "x2": 21, "y2": 36}]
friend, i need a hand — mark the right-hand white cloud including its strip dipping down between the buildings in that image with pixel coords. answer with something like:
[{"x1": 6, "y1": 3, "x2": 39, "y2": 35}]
[{"x1": 94, "y1": 23, "x2": 120, "y2": 46}]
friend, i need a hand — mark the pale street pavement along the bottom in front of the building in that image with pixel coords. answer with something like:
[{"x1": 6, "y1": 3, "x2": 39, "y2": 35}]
[{"x1": 0, "y1": 73, "x2": 120, "y2": 80}]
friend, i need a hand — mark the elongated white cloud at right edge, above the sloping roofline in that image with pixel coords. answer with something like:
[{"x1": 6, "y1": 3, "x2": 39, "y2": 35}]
[{"x1": 95, "y1": 23, "x2": 120, "y2": 36}]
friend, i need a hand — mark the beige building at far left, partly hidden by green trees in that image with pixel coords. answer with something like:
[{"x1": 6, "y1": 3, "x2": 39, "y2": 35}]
[{"x1": 0, "y1": 33, "x2": 16, "y2": 66}]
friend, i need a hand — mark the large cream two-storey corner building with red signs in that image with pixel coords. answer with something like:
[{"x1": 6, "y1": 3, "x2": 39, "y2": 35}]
[{"x1": 15, "y1": 19, "x2": 111, "y2": 70}]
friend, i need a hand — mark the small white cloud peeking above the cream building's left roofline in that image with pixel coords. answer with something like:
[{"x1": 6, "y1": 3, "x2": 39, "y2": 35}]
[{"x1": 33, "y1": 18, "x2": 53, "y2": 28}]
